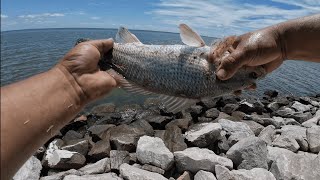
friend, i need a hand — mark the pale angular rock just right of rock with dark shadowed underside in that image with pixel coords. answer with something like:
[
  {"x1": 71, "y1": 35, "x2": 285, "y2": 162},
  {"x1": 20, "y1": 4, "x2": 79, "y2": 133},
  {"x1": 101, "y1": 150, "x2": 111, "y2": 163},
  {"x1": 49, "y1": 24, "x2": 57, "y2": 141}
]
[{"x1": 218, "y1": 119, "x2": 254, "y2": 146}]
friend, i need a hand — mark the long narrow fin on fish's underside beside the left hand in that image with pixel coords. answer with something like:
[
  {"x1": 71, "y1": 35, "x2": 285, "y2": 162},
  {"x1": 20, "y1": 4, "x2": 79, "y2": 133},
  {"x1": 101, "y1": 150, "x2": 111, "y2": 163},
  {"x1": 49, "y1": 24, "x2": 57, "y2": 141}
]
[{"x1": 107, "y1": 69, "x2": 154, "y2": 95}]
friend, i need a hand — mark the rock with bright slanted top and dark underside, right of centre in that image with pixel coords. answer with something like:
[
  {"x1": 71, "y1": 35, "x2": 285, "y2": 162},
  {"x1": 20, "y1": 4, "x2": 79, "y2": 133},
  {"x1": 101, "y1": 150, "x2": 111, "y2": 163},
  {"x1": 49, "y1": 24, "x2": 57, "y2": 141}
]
[{"x1": 185, "y1": 123, "x2": 222, "y2": 147}]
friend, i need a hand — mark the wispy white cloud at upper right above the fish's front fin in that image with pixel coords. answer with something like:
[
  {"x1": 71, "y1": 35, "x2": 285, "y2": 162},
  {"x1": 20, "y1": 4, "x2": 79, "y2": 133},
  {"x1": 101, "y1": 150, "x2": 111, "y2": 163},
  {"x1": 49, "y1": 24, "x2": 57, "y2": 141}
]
[{"x1": 147, "y1": 0, "x2": 320, "y2": 36}]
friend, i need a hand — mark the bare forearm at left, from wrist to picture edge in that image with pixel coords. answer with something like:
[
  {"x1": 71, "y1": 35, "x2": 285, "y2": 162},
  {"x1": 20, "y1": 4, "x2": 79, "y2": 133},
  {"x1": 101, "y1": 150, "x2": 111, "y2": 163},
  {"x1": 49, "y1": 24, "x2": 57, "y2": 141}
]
[{"x1": 1, "y1": 65, "x2": 84, "y2": 179}]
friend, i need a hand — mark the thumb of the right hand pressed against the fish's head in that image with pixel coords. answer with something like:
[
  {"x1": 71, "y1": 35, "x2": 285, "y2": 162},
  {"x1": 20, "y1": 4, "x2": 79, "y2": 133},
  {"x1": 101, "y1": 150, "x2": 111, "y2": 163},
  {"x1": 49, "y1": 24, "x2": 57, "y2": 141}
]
[{"x1": 216, "y1": 49, "x2": 249, "y2": 80}]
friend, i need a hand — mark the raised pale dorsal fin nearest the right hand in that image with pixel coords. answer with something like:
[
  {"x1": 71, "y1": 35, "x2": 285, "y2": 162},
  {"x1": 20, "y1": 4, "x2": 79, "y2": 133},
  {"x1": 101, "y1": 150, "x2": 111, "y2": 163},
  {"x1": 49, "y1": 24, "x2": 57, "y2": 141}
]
[{"x1": 179, "y1": 24, "x2": 206, "y2": 47}]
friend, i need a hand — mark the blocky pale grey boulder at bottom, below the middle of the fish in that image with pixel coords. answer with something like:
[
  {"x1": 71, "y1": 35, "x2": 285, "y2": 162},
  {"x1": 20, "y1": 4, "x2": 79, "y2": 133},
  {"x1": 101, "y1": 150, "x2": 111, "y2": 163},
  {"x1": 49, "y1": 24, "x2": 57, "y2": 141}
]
[{"x1": 136, "y1": 136, "x2": 174, "y2": 170}]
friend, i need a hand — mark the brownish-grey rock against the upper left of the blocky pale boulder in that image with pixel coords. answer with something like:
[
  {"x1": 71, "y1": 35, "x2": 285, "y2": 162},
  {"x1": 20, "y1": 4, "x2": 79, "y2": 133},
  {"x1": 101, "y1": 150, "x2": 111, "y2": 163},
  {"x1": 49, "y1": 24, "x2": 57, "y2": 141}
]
[{"x1": 110, "y1": 124, "x2": 146, "y2": 152}]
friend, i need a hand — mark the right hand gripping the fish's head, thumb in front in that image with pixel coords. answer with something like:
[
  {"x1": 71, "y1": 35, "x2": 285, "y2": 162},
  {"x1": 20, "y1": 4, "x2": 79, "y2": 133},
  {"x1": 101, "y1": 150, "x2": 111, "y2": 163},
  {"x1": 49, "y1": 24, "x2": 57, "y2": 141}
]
[{"x1": 209, "y1": 28, "x2": 284, "y2": 80}]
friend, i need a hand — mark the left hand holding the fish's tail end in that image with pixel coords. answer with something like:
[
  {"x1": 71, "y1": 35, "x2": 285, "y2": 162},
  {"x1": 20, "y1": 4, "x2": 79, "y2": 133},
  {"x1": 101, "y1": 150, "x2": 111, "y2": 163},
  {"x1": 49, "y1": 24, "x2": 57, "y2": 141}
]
[{"x1": 56, "y1": 39, "x2": 117, "y2": 103}]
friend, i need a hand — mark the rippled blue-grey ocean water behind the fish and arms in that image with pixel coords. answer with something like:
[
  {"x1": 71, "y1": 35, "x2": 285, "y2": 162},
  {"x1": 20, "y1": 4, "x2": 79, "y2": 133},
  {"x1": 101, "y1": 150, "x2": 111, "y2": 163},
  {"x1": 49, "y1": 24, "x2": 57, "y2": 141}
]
[{"x1": 1, "y1": 29, "x2": 320, "y2": 108}]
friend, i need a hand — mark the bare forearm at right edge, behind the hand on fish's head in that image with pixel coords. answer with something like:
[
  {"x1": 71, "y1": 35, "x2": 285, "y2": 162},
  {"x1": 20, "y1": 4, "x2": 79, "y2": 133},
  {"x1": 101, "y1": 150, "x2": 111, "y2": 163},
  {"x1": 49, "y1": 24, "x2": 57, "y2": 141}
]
[{"x1": 276, "y1": 14, "x2": 320, "y2": 62}]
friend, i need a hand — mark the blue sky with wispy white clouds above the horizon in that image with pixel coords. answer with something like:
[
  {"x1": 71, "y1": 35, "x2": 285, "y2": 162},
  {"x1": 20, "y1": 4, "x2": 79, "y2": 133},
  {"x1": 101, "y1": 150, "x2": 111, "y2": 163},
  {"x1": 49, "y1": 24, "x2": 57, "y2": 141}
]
[{"x1": 1, "y1": 0, "x2": 320, "y2": 37}]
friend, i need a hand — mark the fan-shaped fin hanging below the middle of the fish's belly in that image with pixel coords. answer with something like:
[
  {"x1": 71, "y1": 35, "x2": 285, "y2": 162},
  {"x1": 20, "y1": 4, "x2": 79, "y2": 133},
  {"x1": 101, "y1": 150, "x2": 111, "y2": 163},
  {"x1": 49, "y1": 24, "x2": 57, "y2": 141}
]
[{"x1": 159, "y1": 94, "x2": 198, "y2": 113}]
